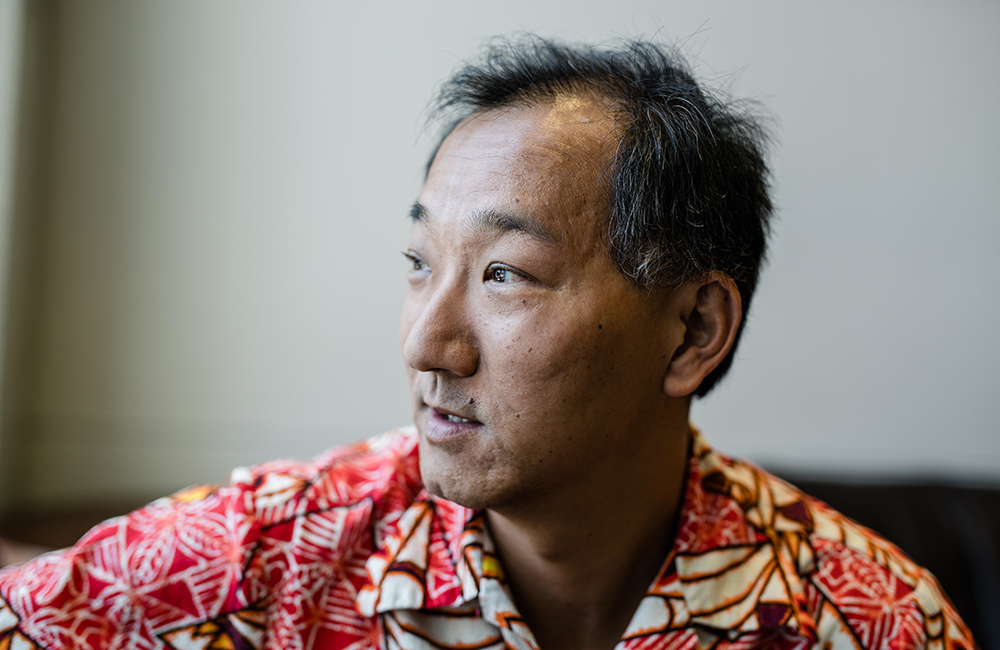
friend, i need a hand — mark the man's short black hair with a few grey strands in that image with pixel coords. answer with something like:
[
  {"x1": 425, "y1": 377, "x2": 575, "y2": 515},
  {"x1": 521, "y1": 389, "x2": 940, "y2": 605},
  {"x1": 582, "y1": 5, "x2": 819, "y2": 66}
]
[{"x1": 428, "y1": 35, "x2": 772, "y2": 397}]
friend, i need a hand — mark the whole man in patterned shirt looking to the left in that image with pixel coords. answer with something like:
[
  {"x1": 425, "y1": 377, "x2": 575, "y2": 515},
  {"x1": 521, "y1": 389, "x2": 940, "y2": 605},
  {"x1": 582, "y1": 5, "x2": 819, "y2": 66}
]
[{"x1": 0, "y1": 38, "x2": 974, "y2": 650}]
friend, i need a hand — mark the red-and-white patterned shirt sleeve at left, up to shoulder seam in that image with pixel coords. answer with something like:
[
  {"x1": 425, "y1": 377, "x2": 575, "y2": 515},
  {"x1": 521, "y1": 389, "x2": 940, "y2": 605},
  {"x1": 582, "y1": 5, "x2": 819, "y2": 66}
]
[{"x1": 0, "y1": 484, "x2": 258, "y2": 649}]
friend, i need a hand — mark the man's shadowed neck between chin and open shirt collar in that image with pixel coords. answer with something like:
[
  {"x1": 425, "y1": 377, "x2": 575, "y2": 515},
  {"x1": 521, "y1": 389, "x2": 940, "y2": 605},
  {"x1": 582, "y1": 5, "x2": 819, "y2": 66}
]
[{"x1": 487, "y1": 420, "x2": 689, "y2": 650}]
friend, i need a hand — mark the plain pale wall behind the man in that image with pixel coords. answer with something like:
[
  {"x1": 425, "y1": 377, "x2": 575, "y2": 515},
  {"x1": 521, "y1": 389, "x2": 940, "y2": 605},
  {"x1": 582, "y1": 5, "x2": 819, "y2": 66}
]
[{"x1": 3, "y1": 0, "x2": 1000, "y2": 504}]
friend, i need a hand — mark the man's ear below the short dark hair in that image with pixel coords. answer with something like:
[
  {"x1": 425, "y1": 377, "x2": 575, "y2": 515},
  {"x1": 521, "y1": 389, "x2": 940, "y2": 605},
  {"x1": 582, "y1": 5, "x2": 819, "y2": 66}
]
[{"x1": 663, "y1": 271, "x2": 743, "y2": 397}]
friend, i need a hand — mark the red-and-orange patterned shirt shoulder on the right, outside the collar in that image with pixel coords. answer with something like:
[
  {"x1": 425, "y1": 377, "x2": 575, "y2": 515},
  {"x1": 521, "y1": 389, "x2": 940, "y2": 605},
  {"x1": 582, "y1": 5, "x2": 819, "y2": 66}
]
[{"x1": 702, "y1": 442, "x2": 974, "y2": 649}]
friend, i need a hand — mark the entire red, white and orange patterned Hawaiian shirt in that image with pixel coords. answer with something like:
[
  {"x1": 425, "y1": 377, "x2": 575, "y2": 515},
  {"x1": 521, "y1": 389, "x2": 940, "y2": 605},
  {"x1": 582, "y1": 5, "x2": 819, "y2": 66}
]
[{"x1": 0, "y1": 429, "x2": 974, "y2": 650}]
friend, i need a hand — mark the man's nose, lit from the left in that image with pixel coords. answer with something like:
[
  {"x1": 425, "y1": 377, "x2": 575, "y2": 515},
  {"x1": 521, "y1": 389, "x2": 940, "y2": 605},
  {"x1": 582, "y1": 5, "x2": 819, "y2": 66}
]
[{"x1": 403, "y1": 278, "x2": 479, "y2": 377}]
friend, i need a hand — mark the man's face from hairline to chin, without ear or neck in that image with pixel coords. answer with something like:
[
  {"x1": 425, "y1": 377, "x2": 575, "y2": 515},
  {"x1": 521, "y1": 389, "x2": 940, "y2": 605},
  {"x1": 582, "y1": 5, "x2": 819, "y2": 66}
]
[{"x1": 400, "y1": 96, "x2": 679, "y2": 508}]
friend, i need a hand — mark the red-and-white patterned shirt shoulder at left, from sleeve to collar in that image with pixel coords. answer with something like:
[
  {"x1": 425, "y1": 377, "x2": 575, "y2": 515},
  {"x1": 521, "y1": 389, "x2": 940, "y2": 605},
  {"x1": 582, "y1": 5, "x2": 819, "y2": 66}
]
[{"x1": 0, "y1": 429, "x2": 422, "y2": 648}]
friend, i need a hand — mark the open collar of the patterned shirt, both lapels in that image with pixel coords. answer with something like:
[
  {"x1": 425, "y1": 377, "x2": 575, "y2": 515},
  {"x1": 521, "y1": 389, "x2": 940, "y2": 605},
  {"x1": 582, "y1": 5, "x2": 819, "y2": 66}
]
[{"x1": 358, "y1": 429, "x2": 816, "y2": 641}]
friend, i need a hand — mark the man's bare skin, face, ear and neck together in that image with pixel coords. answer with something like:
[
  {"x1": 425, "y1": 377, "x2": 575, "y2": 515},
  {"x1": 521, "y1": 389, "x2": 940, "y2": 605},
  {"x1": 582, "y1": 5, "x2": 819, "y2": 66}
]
[{"x1": 400, "y1": 94, "x2": 740, "y2": 650}]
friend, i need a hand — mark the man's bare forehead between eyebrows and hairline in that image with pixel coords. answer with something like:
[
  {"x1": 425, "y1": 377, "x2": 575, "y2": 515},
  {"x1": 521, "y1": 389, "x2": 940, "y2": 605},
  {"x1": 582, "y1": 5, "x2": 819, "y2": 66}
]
[{"x1": 413, "y1": 96, "x2": 612, "y2": 249}]
